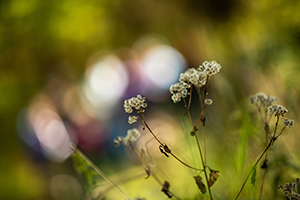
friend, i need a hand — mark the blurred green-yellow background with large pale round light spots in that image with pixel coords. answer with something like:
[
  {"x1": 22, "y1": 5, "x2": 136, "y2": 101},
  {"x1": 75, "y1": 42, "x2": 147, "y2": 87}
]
[{"x1": 0, "y1": 0, "x2": 300, "y2": 199}]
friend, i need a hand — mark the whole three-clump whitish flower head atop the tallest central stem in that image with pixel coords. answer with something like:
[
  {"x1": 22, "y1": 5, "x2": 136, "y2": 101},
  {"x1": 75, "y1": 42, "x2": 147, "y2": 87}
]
[{"x1": 170, "y1": 61, "x2": 221, "y2": 103}]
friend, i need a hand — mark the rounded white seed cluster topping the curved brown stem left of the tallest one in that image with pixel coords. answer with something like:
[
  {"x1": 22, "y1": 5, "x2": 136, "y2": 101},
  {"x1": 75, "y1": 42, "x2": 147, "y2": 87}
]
[{"x1": 124, "y1": 95, "x2": 147, "y2": 113}]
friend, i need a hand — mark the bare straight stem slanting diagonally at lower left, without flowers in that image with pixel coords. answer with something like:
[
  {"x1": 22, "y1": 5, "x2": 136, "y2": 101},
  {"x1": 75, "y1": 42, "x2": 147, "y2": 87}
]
[{"x1": 70, "y1": 143, "x2": 129, "y2": 200}]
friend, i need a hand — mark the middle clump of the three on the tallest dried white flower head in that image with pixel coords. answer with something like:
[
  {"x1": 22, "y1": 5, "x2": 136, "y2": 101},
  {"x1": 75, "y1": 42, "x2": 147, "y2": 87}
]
[{"x1": 179, "y1": 68, "x2": 207, "y2": 87}]
